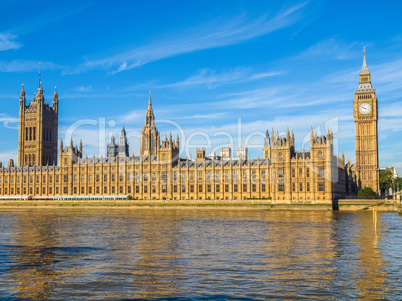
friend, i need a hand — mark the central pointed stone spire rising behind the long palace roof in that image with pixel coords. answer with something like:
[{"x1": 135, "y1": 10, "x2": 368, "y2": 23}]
[{"x1": 140, "y1": 92, "x2": 160, "y2": 156}]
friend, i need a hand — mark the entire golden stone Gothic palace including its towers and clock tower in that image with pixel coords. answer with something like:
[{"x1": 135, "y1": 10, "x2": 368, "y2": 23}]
[{"x1": 0, "y1": 54, "x2": 379, "y2": 203}]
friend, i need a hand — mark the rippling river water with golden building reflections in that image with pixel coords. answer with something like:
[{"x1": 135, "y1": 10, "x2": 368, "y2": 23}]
[{"x1": 0, "y1": 209, "x2": 402, "y2": 300}]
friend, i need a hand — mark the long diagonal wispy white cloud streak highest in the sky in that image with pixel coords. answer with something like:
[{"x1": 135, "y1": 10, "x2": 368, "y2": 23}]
[{"x1": 65, "y1": 2, "x2": 307, "y2": 73}]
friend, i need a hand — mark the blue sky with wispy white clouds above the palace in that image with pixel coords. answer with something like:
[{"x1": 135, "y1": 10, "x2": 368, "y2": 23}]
[{"x1": 0, "y1": 0, "x2": 402, "y2": 173}]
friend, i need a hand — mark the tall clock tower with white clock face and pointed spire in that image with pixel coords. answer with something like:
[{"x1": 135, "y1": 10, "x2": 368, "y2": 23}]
[{"x1": 353, "y1": 51, "x2": 380, "y2": 193}]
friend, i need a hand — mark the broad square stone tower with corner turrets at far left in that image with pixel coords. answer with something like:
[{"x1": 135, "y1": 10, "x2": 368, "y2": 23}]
[{"x1": 18, "y1": 73, "x2": 59, "y2": 166}]
